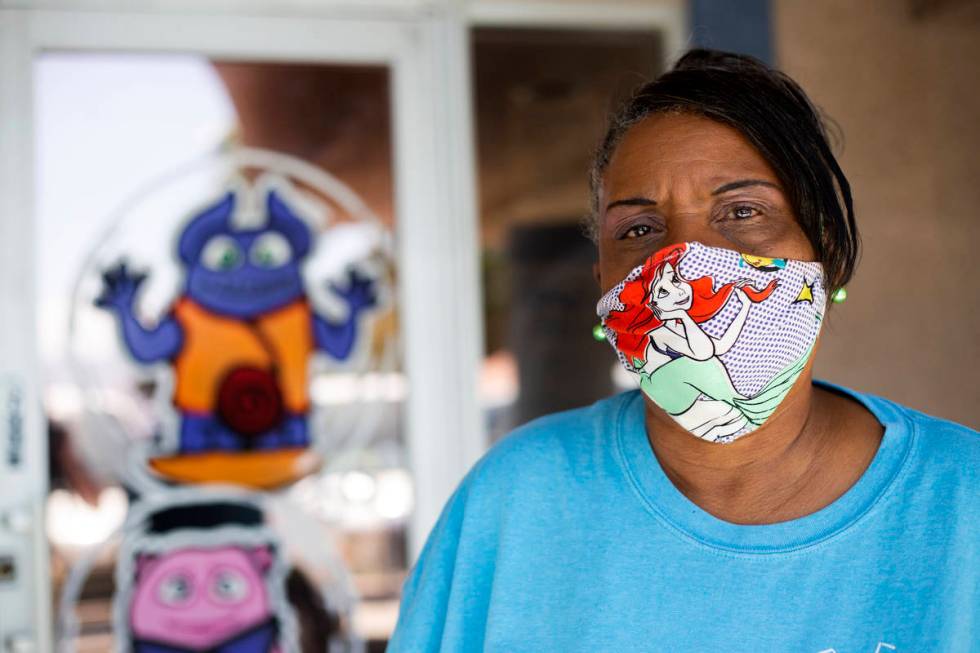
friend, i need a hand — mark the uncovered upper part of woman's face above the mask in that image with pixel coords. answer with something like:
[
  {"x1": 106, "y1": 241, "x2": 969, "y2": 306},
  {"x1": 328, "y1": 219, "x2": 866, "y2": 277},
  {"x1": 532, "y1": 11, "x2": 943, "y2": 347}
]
[{"x1": 596, "y1": 114, "x2": 815, "y2": 292}]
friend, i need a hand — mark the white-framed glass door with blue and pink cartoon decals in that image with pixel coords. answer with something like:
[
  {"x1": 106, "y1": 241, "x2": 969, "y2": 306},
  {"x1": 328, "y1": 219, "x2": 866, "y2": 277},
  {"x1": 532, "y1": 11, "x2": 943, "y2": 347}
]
[{"x1": 0, "y1": 7, "x2": 482, "y2": 651}]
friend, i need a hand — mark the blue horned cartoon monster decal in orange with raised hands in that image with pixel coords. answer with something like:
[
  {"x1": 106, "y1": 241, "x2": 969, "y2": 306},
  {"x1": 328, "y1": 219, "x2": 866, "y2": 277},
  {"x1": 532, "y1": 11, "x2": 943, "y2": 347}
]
[{"x1": 96, "y1": 179, "x2": 376, "y2": 487}]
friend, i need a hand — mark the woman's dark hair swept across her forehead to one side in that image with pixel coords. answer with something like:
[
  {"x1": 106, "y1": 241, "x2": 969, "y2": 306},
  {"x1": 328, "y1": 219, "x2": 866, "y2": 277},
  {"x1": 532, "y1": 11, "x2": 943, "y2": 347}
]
[{"x1": 587, "y1": 50, "x2": 859, "y2": 291}]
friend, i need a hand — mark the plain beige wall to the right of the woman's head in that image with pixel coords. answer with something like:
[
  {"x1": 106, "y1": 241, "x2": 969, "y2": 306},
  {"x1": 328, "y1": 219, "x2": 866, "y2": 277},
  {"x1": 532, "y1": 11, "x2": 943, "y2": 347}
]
[{"x1": 773, "y1": 0, "x2": 980, "y2": 428}]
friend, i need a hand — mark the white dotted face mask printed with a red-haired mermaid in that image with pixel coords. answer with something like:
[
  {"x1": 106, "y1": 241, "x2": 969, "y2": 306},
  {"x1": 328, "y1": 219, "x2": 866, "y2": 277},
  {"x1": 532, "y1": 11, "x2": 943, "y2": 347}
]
[{"x1": 596, "y1": 242, "x2": 826, "y2": 442}]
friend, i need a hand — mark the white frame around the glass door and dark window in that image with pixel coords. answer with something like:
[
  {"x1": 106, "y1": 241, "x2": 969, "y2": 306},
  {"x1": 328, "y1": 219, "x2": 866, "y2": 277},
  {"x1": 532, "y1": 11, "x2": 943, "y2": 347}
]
[{"x1": 0, "y1": 0, "x2": 686, "y2": 640}]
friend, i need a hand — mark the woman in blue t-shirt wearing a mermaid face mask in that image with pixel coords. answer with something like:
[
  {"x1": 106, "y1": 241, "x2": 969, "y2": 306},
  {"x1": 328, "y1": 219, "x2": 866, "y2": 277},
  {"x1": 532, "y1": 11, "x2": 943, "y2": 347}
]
[{"x1": 389, "y1": 50, "x2": 980, "y2": 653}]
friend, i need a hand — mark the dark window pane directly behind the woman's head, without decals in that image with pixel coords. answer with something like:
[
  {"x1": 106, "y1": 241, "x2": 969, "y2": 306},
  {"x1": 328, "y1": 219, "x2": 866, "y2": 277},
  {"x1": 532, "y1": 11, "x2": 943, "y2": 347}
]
[{"x1": 473, "y1": 28, "x2": 662, "y2": 438}]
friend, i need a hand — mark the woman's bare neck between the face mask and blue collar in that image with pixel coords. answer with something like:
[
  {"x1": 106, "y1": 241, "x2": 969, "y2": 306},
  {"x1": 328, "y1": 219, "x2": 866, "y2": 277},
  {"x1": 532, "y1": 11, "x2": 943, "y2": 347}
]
[{"x1": 646, "y1": 368, "x2": 883, "y2": 524}]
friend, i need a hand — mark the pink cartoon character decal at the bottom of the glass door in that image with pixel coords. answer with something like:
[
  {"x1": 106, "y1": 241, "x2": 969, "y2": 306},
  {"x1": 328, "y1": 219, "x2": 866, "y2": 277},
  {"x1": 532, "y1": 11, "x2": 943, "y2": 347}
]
[{"x1": 113, "y1": 500, "x2": 298, "y2": 653}]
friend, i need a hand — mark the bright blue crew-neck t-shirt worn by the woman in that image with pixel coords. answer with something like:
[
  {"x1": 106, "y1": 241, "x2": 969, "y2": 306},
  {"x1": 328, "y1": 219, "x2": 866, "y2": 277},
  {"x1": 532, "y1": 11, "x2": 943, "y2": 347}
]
[{"x1": 388, "y1": 388, "x2": 980, "y2": 653}]
